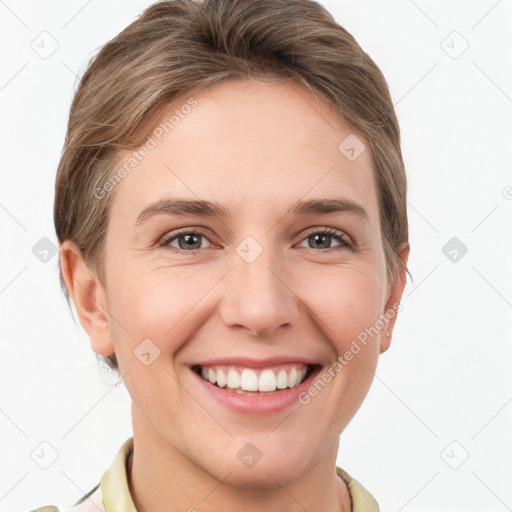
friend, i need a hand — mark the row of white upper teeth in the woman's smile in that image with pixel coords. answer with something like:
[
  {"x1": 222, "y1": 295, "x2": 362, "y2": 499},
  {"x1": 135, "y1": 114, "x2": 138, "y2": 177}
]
[{"x1": 201, "y1": 365, "x2": 307, "y2": 392}]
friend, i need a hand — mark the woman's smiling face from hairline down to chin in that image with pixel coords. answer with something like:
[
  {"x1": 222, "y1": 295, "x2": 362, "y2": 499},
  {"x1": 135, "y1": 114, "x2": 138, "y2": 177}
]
[{"x1": 87, "y1": 81, "x2": 403, "y2": 486}]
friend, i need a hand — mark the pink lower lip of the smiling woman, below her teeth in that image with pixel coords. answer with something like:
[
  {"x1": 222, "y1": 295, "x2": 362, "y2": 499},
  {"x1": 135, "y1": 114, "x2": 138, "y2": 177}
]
[{"x1": 191, "y1": 368, "x2": 321, "y2": 416}]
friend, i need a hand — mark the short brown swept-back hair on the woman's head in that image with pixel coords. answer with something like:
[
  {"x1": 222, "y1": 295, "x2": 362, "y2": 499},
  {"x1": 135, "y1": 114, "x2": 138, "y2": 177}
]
[{"x1": 54, "y1": 0, "x2": 408, "y2": 370}]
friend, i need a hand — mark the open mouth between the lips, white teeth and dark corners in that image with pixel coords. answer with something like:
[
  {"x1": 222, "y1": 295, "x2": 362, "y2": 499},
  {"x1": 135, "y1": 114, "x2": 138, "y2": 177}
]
[{"x1": 192, "y1": 364, "x2": 320, "y2": 395}]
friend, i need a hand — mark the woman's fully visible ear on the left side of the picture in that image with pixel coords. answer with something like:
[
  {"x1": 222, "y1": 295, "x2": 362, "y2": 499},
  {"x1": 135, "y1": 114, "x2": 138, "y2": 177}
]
[{"x1": 59, "y1": 240, "x2": 114, "y2": 356}]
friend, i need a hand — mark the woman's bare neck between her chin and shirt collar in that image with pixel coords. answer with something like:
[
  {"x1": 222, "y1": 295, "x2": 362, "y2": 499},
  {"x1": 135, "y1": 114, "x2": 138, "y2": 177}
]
[{"x1": 127, "y1": 406, "x2": 352, "y2": 512}]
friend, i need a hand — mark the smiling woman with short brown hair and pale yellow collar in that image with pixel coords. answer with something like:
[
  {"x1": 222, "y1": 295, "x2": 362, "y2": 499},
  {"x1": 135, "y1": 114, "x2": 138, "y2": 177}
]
[{"x1": 33, "y1": 0, "x2": 409, "y2": 512}]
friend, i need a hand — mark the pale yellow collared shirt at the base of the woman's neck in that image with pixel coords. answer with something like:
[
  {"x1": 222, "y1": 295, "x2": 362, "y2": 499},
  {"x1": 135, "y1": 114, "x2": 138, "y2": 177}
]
[{"x1": 32, "y1": 437, "x2": 380, "y2": 512}]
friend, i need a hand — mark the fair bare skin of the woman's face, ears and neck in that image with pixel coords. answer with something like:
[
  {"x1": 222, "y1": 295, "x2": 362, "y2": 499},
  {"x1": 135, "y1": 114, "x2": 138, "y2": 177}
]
[{"x1": 60, "y1": 80, "x2": 409, "y2": 512}]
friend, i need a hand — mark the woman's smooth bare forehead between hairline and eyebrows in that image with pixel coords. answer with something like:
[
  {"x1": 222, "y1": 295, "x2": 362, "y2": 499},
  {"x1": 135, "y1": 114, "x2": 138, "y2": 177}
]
[{"x1": 109, "y1": 80, "x2": 378, "y2": 222}]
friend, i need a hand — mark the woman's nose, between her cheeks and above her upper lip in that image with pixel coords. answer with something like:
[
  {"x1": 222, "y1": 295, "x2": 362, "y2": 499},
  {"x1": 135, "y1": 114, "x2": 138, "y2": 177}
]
[{"x1": 220, "y1": 245, "x2": 300, "y2": 338}]
